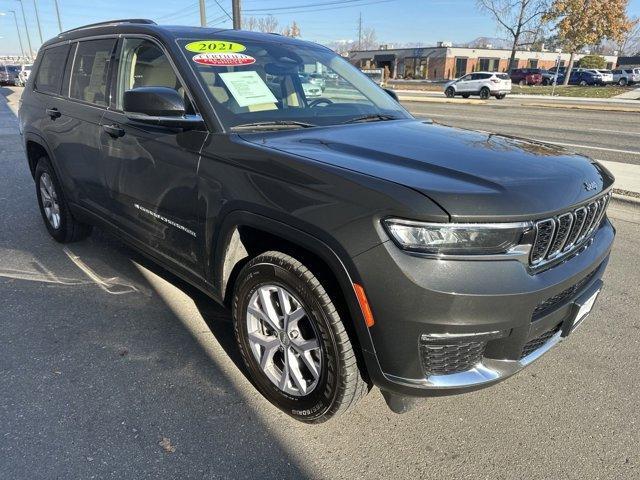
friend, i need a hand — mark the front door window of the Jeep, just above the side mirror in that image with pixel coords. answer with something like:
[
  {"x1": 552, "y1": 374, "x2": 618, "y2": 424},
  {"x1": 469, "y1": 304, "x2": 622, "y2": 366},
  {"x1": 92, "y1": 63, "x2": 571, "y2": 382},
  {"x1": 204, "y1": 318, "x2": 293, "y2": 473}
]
[{"x1": 116, "y1": 38, "x2": 189, "y2": 110}]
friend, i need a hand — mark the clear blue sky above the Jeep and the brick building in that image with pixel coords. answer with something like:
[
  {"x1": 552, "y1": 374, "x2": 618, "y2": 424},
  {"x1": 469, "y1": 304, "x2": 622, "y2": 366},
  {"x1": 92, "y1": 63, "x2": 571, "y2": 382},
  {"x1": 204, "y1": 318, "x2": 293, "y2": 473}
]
[{"x1": 0, "y1": 0, "x2": 640, "y2": 54}]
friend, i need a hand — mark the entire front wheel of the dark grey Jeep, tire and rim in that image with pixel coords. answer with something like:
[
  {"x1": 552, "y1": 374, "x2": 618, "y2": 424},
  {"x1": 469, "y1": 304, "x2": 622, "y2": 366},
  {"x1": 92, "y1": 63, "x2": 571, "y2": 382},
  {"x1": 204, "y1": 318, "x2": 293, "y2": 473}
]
[{"x1": 232, "y1": 251, "x2": 369, "y2": 423}]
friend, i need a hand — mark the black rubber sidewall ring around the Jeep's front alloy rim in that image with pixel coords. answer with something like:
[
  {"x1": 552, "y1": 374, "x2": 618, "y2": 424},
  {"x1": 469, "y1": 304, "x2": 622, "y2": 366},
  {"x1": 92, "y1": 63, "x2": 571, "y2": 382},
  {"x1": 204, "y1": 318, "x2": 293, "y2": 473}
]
[{"x1": 233, "y1": 263, "x2": 340, "y2": 422}]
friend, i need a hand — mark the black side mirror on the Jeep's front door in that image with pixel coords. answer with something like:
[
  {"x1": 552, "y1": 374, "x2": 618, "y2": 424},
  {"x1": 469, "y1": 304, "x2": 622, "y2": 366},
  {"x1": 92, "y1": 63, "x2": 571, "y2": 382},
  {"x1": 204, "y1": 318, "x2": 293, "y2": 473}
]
[{"x1": 122, "y1": 87, "x2": 204, "y2": 129}]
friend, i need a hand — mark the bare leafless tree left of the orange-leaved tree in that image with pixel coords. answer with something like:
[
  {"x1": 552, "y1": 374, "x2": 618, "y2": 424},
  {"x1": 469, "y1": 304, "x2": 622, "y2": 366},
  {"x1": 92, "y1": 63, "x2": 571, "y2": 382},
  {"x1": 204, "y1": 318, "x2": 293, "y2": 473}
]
[{"x1": 477, "y1": 0, "x2": 549, "y2": 69}]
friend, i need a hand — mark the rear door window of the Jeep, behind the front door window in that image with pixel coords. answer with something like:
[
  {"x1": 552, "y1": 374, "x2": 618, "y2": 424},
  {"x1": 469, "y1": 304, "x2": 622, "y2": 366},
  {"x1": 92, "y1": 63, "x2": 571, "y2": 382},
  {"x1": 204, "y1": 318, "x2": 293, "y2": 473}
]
[{"x1": 69, "y1": 39, "x2": 116, "y2": 106}]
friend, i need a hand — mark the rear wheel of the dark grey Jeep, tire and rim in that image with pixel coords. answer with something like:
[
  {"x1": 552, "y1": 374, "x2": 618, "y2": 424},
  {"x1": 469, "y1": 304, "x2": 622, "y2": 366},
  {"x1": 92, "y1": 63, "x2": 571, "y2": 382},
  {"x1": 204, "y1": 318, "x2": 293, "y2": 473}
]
[{"x1": 35, "y1": 157, "x2": 92, "y2": 243}]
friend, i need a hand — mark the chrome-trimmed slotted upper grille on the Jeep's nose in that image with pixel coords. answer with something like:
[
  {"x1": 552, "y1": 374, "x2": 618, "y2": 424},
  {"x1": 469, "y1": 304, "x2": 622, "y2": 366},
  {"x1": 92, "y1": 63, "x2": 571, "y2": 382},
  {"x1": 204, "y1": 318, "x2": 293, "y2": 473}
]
[{"x1": 531, "y1": 193, "x2": 611, "y2": 267}]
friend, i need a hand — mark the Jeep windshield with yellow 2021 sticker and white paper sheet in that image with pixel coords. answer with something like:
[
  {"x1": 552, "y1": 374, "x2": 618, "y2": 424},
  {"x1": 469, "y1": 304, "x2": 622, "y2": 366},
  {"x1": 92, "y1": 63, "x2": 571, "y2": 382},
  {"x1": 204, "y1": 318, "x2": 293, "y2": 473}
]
[{"x1": 178, "y1": 37, "x2": 412, "y2": 129}]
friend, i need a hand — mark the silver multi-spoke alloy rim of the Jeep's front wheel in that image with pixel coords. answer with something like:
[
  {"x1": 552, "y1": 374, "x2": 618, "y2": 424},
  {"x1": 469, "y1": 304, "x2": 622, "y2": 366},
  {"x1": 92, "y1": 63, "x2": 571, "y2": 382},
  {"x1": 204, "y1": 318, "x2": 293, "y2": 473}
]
[{"x1": 246, "y1": 284, "x2": 323, "y2": 396}]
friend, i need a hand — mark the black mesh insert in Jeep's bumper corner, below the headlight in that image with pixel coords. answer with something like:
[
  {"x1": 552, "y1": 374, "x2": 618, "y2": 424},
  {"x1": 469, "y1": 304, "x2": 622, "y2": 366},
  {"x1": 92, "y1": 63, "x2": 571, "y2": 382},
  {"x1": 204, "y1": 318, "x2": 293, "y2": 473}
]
[{"x1": 420, "y1": 342, "x2": 487, "y2": 376}]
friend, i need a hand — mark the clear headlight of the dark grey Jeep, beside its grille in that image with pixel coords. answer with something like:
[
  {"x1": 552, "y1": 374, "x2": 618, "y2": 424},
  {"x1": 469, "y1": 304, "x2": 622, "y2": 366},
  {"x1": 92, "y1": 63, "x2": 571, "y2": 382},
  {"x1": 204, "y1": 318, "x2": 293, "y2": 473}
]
[{"x1": 384, "y1": 219, "x2": 532, "y2": 255}]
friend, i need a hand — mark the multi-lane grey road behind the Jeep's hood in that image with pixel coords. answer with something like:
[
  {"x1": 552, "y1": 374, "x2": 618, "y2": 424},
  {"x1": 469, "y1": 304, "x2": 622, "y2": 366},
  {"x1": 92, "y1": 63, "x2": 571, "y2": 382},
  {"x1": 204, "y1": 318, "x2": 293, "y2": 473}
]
[{"x1": 404, "y1": 98, "x2": 640, "y2": 165}]
